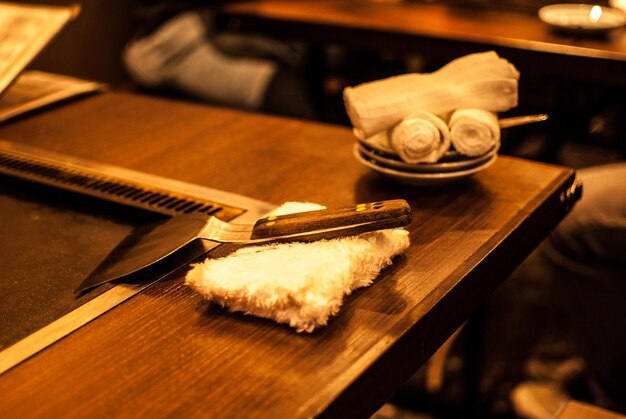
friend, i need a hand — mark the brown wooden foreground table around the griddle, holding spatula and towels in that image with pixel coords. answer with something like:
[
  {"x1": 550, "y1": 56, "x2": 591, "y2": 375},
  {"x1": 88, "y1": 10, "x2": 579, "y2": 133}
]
[{"x1": 0, "y1": 92, "x2": 575, "y2": 418}]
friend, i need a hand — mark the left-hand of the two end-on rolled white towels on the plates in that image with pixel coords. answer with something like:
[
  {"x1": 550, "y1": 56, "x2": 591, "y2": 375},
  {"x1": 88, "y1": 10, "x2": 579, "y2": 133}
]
[{"x1": 390, "y1": 112, "x2": 450, "y2": 163}]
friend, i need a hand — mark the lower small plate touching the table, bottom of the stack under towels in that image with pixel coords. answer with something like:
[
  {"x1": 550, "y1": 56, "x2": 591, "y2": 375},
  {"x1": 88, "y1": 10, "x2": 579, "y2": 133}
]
[{"x1": 353, "y1": 144, "x2": 498, "y2": 186}]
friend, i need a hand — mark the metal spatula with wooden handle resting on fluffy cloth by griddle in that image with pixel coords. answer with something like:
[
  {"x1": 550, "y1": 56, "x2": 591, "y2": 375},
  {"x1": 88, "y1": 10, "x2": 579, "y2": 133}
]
[{"x1": 76, "y1": 199, "x2": 411, "y2": 292}]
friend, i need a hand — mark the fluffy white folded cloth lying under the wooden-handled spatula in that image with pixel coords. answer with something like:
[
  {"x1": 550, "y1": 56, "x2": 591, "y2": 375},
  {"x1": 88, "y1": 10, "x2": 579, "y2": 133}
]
[{"x1": 185, "y1": 202, "x2": 409, "y2": 332}]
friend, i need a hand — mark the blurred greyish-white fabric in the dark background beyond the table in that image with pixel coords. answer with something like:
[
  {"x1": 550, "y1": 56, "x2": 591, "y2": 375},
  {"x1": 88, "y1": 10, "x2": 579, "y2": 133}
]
[{"x1": 123, "y1": 12, "x2": 278, "y2": 109}]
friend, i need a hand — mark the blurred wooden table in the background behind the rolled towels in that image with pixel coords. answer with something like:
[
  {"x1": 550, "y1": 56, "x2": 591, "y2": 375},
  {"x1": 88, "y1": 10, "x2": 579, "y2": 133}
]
[{"x1": 220, "y1": 0, "x2": 626, "y2": 86}]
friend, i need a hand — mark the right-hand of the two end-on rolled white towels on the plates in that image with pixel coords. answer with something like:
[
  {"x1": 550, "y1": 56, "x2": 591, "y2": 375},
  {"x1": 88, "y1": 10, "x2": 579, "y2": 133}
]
[{"x1": 448, "y1": 109, "x2": 500, "y2": 157}]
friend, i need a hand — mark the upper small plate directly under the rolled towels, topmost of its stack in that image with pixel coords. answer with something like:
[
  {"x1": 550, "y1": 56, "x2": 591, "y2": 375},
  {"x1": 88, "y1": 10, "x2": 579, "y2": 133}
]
[{"x1": 356, "y1": 143, "x2": 498, "y2": 173}]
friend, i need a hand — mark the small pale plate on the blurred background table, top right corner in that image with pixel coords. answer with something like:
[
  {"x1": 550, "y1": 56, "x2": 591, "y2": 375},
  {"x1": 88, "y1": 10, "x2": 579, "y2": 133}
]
[{"x1": 539, "y1": 3, "x2": 626, "y2": 32}]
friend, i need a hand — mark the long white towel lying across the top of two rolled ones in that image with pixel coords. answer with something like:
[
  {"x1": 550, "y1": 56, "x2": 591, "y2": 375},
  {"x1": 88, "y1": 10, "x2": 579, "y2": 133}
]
[{"x1": 343, "y1": 51, "x2": 519, "y2": 139}]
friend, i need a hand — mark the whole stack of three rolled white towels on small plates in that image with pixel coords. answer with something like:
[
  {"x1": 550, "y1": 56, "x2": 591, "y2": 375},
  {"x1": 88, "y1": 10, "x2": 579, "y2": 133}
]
[{"x1": 344, "y1": 51, "x2": 519, "y2": 163}]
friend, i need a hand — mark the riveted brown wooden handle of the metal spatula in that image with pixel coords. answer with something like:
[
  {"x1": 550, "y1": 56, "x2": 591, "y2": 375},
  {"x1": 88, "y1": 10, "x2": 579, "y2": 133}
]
[{"x1": 251, "y1": 199, "x2": 411, "y2": 240}]
